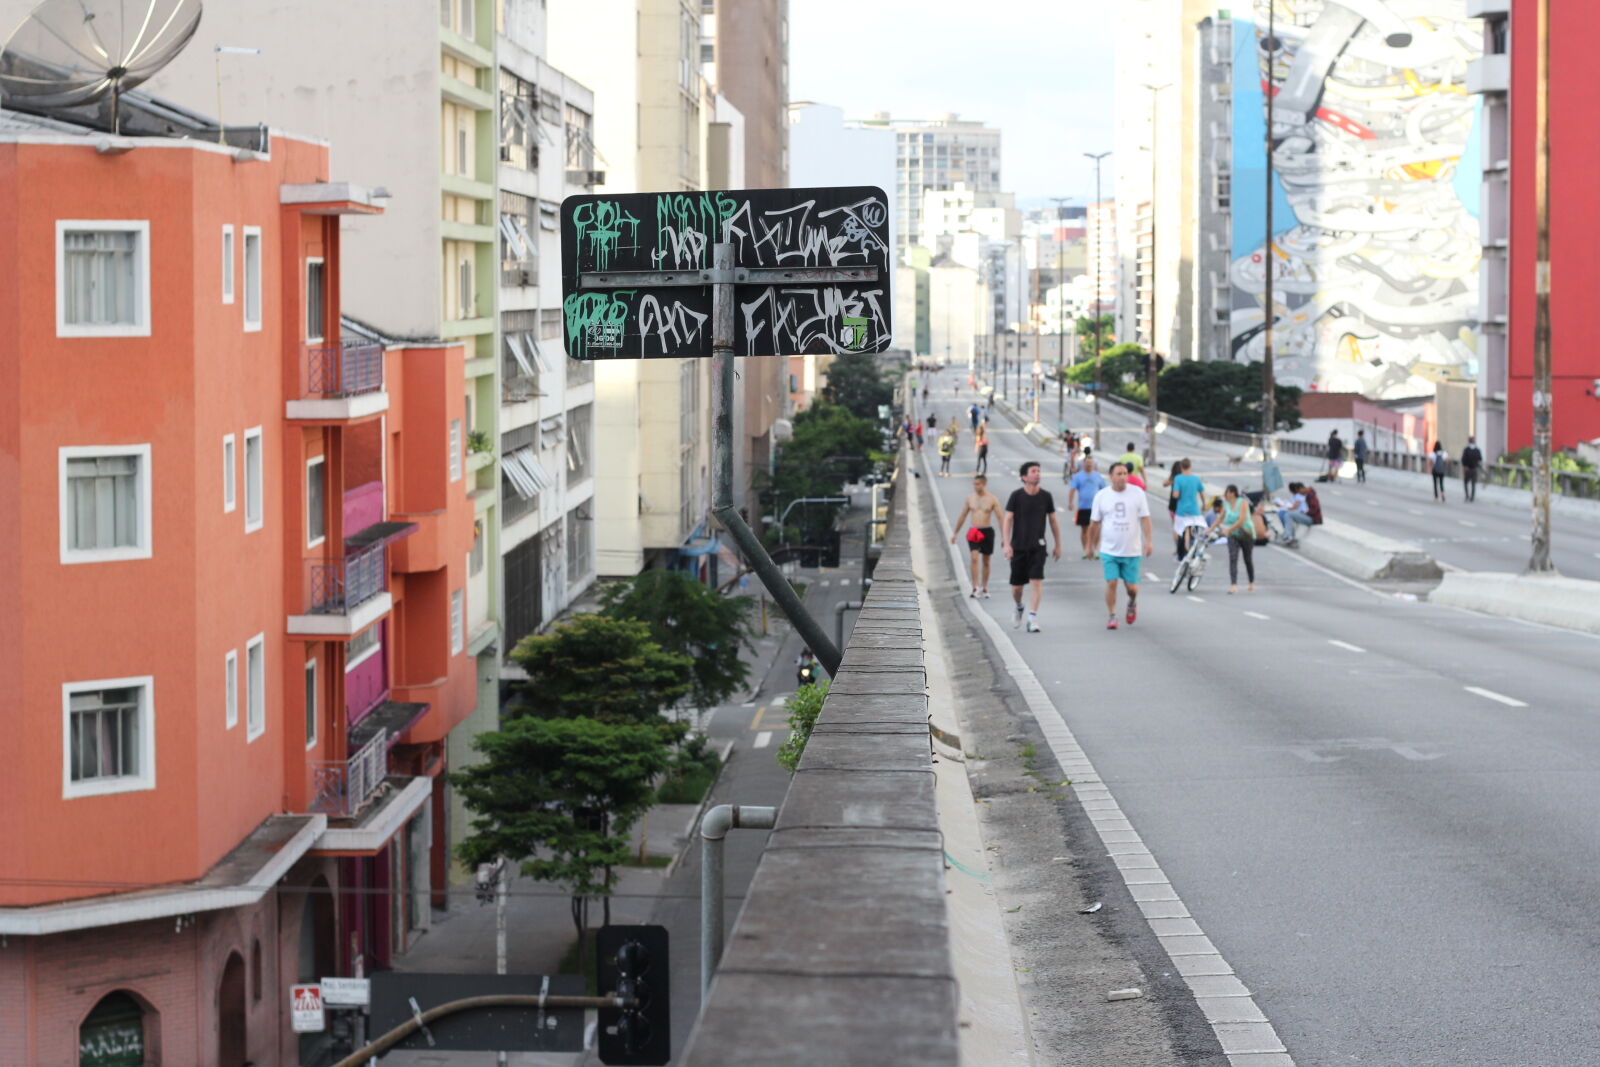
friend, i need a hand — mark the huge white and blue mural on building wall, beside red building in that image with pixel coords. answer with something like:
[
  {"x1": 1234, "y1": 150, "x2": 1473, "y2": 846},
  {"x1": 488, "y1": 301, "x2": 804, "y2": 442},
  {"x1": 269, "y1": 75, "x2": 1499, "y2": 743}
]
[{"x1": 1230, "y1": 0, "x2": 1483, "y2": 398}]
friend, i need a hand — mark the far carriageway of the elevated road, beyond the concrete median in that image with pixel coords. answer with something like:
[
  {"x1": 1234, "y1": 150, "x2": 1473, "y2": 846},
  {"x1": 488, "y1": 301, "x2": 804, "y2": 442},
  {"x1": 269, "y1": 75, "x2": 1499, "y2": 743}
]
[{"x1": 918, "y1": 379, "x2": 1600, "y2": 581}]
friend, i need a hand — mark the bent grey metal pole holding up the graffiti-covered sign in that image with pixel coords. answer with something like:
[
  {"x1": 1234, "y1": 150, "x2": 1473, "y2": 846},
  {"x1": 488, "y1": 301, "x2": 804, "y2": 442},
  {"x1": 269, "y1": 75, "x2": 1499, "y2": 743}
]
[{"x1": 710, "y1": 242, "x2": 840, "y2": 677}]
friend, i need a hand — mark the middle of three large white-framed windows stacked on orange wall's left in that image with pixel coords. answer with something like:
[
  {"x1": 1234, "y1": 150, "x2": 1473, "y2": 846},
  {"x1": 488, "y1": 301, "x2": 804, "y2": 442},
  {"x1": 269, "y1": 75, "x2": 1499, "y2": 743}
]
[{"x1": 59, "y1": 445, "x2": 150, "y2": 563}]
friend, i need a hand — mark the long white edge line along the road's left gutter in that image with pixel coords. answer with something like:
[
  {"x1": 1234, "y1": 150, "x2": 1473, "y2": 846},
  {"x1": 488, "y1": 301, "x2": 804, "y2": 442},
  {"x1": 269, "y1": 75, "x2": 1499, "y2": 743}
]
[{"x1": 912, "y1": 467, "x2": 1292, "y2": 1067}]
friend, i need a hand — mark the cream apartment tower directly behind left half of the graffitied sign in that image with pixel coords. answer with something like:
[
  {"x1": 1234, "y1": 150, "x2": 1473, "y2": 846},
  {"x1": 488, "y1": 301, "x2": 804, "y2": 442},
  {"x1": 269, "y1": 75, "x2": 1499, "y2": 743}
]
[{"x1": 549, "y1": 0, "x2": 717, "y2": 577}]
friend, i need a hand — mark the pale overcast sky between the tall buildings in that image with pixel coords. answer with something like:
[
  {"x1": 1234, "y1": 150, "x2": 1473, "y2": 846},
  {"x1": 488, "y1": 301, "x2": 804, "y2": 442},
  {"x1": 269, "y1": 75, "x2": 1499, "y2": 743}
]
[{"x1": 789, "y1": 0, "x2": 1123, "y2": 206}]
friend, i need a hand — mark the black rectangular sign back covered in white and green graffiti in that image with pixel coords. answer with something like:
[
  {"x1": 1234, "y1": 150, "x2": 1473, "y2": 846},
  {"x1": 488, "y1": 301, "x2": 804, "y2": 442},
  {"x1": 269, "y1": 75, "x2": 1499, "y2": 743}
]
[{"x1": 562, "y1": 186, "x2": 891, "y2": 360}]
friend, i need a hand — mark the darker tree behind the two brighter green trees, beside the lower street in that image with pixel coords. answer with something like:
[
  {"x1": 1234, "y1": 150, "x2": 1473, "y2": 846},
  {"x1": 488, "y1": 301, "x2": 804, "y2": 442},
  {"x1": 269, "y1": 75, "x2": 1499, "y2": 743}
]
[{"x1": 600, "y1": 571, "x2": 750, "y2": 707}]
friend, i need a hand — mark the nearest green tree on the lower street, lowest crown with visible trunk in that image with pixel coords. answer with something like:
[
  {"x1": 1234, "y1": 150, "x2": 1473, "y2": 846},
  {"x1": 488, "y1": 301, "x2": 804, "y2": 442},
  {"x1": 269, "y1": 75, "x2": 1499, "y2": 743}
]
[{"x1": 450, "y1": 715, "x2": 669, "y2": 973}]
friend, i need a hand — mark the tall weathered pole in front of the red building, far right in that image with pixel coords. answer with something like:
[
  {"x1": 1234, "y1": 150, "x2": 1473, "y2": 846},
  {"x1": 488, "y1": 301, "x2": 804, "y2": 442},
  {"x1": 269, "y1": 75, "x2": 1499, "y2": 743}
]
[{"x1": 1528, "y1": 0, "x2": 1555, "y2": 574}]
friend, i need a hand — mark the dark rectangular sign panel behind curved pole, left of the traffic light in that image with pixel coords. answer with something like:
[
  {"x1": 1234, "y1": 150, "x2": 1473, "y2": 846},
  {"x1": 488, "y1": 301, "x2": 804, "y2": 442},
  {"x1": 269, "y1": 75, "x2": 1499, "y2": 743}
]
[{"x1": 370, "y1": 971, "x2": 584, "y2": 1053}]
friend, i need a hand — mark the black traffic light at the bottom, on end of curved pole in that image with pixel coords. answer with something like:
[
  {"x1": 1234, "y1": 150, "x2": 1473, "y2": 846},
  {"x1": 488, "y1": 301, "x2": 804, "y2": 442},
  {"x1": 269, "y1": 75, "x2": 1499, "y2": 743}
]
[{"x1": 595, "y1": 926, "x2": 672, "y2": 1065}]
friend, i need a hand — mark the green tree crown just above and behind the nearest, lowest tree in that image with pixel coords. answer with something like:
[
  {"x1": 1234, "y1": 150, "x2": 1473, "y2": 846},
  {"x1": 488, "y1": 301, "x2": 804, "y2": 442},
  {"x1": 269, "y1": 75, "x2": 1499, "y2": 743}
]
[{"x1": 510, "y1": 614, "x2": 694, "y2": 723}]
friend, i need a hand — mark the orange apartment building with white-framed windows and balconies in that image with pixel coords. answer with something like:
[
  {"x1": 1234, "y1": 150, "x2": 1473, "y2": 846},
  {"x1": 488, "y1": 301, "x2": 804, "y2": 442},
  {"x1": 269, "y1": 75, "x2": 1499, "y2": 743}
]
[{"x1": 0, "y1": 101, "x2": 485, "y2": 1067}]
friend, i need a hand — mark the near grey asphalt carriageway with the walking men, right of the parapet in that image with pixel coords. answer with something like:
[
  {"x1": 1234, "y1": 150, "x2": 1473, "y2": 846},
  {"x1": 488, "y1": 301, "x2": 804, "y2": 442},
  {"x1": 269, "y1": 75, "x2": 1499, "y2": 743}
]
[{"x1": 923, "y1": 373, "x2": 1600, "y2": 1067}]
